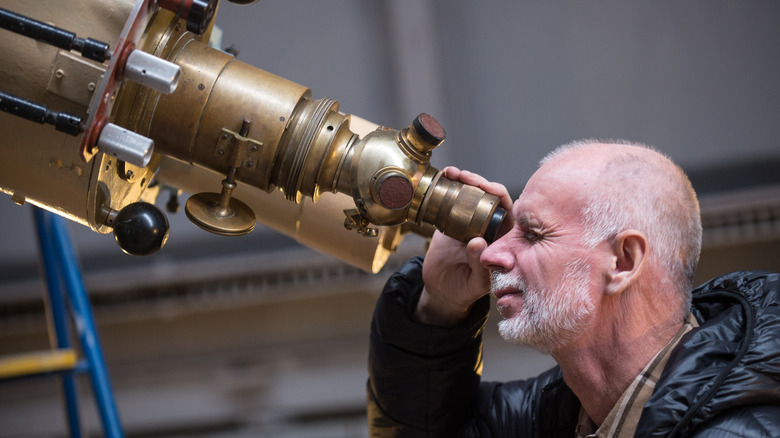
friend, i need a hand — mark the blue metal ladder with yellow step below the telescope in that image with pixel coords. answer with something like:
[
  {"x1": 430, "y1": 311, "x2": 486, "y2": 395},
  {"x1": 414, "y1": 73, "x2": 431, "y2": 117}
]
[{"x1": 0, "y1": 208, "x2": 123, "y2": 438}]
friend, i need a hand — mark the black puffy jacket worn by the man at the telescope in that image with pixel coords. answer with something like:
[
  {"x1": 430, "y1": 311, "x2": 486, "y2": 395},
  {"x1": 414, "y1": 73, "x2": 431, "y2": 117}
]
[{"x1": 368, "y1": 258, "x2": 780, "y2": 438}]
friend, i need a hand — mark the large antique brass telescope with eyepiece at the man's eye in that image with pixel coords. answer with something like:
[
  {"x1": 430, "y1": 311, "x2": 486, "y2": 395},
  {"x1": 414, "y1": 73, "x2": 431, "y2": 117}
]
[{"x1": 0, "y1": 0, "x2": 509, "y2": 272}]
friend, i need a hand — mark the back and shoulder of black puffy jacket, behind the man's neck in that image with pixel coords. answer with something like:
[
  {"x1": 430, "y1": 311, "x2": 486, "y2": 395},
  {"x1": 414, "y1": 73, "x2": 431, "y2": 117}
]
[{"x1": 638, "y1": 271, "x2": 780, "y2": 437}]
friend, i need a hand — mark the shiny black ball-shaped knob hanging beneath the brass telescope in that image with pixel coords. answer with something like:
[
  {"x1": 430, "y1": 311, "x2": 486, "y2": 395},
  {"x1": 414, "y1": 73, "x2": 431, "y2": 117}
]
[{"x1": 113, "y1": 202, "x2": 168, "y2": 256}]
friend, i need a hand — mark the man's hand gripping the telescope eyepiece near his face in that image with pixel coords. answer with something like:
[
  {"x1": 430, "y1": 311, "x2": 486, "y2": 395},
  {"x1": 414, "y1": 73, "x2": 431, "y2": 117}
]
[{"x1": 414, "y1": 167, "x2": 512, "y2": 326}]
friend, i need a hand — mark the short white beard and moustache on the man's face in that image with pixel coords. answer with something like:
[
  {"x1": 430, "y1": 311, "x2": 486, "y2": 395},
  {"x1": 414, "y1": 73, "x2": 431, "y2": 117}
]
[{"x1": 491, "y1": 259, "x2": 595, "y2": 354}]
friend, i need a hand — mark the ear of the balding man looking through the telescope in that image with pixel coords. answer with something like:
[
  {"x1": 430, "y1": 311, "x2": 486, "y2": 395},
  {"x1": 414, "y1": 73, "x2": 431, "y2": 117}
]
[{"x1": 606, "y1": 230, "x2": 649, "y2": 295}]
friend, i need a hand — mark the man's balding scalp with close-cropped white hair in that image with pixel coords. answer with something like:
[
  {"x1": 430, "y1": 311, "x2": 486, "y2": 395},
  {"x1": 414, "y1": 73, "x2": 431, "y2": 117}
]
[{"x1": 539, "y1": 141, "x2": 701, "y2": 308}]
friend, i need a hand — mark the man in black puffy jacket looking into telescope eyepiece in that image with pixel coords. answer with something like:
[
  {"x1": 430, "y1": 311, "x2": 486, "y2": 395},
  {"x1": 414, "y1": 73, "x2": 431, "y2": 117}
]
[{"x1": 368, "y1": 142, "x2": 780, "y2": 438}]
